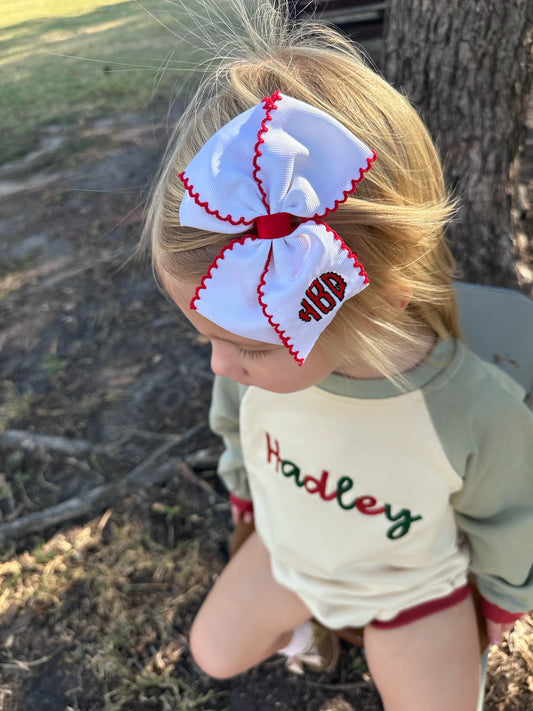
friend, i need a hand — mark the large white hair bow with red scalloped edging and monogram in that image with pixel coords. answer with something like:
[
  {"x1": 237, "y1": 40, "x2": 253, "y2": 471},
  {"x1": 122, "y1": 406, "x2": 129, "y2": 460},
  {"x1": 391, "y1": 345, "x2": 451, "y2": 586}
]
[{"x1": 179, "y1": 92, "x2": 376, "y2": 365}]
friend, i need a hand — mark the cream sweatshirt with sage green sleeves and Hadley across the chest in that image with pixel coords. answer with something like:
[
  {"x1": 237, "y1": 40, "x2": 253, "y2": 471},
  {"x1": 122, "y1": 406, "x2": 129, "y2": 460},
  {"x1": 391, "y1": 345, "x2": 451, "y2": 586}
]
[{"x1": 210, "y1": 341, "x2": 533, "y2": 628}]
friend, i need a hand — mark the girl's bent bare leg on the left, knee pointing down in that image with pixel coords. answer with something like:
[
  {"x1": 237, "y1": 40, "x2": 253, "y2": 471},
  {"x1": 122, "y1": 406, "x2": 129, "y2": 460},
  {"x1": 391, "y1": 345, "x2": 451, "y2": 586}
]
[{"x1": 190, "y1": 533, "x2": 311, "y2": 679}]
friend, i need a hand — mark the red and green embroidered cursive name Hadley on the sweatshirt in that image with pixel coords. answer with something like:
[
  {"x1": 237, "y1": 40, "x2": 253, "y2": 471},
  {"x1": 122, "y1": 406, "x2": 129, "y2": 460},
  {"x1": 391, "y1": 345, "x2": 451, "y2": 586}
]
[{"x1": 265, "y1": 432, "x2": 422, "y2": 540}]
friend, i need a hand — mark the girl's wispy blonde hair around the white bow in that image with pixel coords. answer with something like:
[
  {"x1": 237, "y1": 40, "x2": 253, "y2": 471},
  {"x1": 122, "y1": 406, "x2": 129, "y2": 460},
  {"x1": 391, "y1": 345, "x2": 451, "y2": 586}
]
[{"x1": 144, "y1": 1, "x2": 460, "y2": 379}]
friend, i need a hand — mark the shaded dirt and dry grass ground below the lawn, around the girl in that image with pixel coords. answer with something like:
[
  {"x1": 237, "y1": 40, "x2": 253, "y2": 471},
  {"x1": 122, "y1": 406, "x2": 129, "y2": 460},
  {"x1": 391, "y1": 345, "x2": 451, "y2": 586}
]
[{"x1": 0, "y1": 110, "x2": 533, "y2": 711}]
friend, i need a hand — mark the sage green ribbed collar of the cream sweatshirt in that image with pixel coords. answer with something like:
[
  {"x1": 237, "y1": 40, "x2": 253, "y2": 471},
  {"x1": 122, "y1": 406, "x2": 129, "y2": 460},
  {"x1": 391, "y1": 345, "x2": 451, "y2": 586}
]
[{"x1": 316, "y1": 339, "x2": 456, "y2": 399}]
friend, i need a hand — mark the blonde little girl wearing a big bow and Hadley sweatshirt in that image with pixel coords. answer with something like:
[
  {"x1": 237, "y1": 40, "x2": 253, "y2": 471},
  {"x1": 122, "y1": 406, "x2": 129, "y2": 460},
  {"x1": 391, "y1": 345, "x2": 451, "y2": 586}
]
[{"x1": 140, "y1": 3, "x2": 533, "y2": 711}]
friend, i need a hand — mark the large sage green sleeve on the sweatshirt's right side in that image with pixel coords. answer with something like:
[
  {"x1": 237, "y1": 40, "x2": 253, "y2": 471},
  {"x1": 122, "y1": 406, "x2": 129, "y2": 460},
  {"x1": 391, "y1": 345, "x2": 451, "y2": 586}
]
[{"x1": 428, "y1": 348, "x2": 533, "y2": 612}]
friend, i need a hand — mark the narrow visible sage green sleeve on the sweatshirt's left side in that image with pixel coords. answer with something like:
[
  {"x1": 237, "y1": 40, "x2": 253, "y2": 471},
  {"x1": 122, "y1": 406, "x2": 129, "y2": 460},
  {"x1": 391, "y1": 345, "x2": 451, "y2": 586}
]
[{"x1": 209, "y1": 375, "x2": 252, "y2": 500}]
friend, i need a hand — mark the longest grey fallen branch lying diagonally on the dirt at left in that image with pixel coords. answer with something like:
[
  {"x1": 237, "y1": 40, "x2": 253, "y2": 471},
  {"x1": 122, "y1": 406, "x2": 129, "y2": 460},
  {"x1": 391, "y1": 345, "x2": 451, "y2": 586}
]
[{"x1": 0, "y1": 425, "x2": 204, "y2": 544}]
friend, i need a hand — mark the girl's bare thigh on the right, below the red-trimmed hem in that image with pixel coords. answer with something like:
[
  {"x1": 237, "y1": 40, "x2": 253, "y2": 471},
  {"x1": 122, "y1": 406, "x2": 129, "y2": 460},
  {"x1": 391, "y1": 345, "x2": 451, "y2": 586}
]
[{"x1": 365, "y1": 598, "x2": 480, "y2": 711}]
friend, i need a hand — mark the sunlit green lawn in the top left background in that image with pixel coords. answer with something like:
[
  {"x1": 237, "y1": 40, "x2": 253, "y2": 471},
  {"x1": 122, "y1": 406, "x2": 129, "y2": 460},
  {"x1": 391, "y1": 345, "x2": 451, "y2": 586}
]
[{"x1": 0, "y1": 0, "x2": 198, "y2": 163}]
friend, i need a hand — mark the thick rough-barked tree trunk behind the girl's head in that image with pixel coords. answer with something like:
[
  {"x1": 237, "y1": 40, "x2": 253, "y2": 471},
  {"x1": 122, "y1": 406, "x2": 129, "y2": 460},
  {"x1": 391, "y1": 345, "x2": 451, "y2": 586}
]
[{"x1": 383, "y1": 0, "x2": 533, "y2": 287}]
